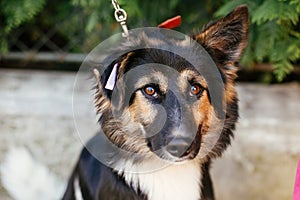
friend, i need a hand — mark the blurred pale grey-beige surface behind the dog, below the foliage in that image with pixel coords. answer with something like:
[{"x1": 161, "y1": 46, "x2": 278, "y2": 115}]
[{"x1": 0, "y1": 69, "x2": 300, "y2": 200}]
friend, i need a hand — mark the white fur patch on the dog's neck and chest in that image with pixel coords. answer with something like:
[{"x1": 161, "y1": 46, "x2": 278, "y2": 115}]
[{"x1": 117, "y1": 160, "x2": 202, "y2": 200}]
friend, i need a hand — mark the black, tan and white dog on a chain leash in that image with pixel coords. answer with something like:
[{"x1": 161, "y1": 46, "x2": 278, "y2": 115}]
[{"x1": 63, "y1": 6, "x2": 249, "y2": 200}]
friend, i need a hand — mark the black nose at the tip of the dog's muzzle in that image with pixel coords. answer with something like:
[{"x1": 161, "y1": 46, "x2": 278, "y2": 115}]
[{"x1": 166, "y1": 139, "x2": 192, "y2": 158}]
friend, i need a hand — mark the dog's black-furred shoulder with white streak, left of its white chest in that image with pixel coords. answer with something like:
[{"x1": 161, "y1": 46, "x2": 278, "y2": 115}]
[{"x1": 63, "y1": 148, "x2": 145, "y2": 200}]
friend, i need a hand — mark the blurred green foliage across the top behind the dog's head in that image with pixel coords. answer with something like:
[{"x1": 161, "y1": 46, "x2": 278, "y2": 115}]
[{"x1": 0, "y1": 0, "x2": 300, "y2": 81}]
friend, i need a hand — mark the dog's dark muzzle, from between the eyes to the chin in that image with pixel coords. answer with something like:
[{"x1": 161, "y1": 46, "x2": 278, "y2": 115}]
[{"x1": 146, "y1": 90, "x2": 201, "y2": 161}]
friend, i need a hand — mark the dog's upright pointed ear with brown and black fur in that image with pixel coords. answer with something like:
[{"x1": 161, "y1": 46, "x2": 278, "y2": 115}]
[{"x1": 193, "y1": 5, "x2": 249, "y2": 77}]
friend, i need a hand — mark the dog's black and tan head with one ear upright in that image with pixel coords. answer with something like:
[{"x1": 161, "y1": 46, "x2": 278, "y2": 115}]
[{"x1": 95, "y1": 6, "x2": 248, "y2": 161}]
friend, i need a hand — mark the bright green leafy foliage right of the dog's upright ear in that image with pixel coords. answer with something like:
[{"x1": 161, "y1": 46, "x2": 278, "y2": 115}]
[{"x1": 215, "y1": 0, "x2": 300, "y2": 81}]
